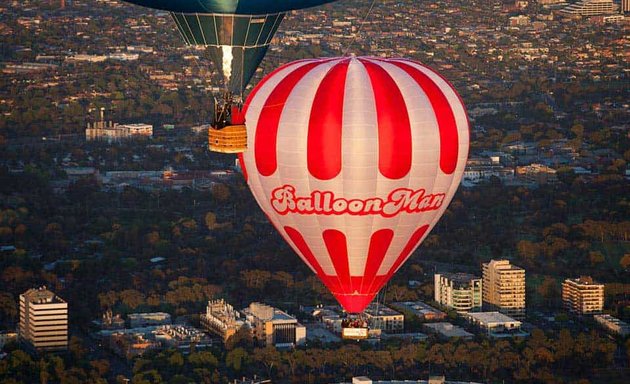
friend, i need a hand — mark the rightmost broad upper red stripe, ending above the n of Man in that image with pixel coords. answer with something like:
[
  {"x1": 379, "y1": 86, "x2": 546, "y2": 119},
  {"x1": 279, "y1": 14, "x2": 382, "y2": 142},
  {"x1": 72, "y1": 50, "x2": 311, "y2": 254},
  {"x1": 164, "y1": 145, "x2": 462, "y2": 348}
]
[{"x1": 388, "y1": 60, "x2": 459, "y2": 175}]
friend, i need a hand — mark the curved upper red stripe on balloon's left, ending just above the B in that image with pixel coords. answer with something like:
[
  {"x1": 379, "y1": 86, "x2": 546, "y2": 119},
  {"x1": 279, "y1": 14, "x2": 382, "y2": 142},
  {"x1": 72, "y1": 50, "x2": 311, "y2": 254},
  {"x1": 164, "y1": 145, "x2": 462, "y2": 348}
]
[{"x1": 254, "y1": 62, "x2": 320, "y2": 176}]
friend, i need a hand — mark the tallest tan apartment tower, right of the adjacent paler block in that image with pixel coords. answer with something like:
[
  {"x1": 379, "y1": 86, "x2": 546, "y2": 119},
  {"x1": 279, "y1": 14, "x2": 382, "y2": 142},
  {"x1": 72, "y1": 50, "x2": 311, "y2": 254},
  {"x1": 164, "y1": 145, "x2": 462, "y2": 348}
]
[{"x1": 483, "y1": 260, "x2": 525, "y2": 319}]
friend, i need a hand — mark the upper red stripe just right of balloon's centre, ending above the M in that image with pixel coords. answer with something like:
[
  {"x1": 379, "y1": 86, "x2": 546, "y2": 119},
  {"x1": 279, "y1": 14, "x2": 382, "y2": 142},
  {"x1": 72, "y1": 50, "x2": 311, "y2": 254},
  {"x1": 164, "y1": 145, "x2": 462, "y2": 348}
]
[{"x1": 359, "y1": 59, "x2": 412, "y2": 179}]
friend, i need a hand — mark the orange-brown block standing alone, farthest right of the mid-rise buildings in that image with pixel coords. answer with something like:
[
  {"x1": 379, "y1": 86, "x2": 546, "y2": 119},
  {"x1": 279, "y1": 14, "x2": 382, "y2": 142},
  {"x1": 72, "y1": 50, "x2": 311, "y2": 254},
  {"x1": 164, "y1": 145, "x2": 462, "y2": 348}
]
[{"x1": 562, "y1": 276, "x2": 604, "y2": 315}]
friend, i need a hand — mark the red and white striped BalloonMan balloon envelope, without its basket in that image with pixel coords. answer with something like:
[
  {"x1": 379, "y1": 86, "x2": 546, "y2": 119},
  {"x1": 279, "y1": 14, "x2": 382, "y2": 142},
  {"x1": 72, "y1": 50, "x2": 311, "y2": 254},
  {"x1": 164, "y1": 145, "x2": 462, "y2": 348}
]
[{"x1": 240, "y1": 57, "x2": 469, "y2": 313}]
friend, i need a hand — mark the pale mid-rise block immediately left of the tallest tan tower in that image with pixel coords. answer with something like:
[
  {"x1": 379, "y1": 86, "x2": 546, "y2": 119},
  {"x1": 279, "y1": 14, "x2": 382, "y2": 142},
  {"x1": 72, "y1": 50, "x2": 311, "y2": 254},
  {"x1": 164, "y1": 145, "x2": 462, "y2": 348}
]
[{"x1": 434, "y1": 273, "x2": 483, "y2": 312}]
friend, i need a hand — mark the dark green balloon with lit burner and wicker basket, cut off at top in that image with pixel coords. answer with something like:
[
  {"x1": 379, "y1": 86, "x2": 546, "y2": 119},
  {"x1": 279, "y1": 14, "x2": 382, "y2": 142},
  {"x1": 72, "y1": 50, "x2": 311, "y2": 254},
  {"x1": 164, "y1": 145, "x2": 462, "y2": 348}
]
[{"x1": 125, "y1": 0, "x2": 335, "y2": 152}]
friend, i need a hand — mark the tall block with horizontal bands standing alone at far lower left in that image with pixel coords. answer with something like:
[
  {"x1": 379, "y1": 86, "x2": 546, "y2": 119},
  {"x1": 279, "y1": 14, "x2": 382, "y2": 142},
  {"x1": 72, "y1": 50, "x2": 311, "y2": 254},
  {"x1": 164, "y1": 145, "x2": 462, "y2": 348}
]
[{"x1": 19, "y1": 287, "x2": 68, "y2": 351}]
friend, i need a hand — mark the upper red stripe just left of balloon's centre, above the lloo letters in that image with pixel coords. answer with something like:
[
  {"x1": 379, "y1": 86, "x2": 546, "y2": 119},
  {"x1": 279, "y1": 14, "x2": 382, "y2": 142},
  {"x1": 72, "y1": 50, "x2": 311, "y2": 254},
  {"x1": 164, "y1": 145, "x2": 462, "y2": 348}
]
[{"x1": 307, "y1": 59, "x2": 350, "y2": 180}]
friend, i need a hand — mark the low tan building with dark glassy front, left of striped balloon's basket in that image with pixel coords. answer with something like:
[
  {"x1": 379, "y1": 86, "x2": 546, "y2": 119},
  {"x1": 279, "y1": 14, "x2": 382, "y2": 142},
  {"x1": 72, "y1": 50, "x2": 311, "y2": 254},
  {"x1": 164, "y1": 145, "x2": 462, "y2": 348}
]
[{"x1": 241, "y1": 303, "x2": 306, "y2": 347}]
